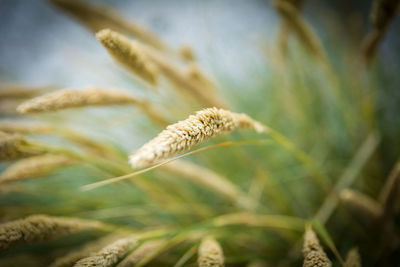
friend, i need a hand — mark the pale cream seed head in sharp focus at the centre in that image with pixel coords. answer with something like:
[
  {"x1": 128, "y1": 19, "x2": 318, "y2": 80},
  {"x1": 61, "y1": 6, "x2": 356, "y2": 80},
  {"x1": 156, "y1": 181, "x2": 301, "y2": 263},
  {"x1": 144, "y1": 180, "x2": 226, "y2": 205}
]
[{"x1": 130, "y1": 108, "x2": 264, "y2": 168}]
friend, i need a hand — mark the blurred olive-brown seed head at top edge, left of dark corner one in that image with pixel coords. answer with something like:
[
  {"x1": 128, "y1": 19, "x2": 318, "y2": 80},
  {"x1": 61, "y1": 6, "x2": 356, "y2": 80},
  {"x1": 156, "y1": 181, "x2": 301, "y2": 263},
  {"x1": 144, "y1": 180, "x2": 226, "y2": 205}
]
[{"x1": 274, "y1": 0, "x2": 326, "y2": 61}]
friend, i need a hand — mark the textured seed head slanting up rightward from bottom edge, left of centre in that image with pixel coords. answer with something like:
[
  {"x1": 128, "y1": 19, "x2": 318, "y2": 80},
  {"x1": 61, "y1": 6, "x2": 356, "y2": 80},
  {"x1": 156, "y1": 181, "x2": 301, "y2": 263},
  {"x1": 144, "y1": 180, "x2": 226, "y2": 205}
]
[{"x1": 74, "y1": 236, "x2": 137, "y2": 267}]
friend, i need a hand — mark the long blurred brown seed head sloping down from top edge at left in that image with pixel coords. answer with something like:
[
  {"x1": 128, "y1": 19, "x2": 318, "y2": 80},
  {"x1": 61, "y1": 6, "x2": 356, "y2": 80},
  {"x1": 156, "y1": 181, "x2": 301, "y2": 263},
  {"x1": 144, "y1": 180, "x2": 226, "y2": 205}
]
[{"x1": 52, "y1": 0, "x2": 167, "y2": 49}]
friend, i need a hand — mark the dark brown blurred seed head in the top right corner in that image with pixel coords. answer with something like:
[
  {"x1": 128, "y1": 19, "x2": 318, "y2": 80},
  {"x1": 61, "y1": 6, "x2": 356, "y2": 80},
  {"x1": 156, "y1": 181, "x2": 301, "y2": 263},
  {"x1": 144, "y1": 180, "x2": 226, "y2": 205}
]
[{"x1": 363, "y1": 0, "x2": 400, "y2": 63}]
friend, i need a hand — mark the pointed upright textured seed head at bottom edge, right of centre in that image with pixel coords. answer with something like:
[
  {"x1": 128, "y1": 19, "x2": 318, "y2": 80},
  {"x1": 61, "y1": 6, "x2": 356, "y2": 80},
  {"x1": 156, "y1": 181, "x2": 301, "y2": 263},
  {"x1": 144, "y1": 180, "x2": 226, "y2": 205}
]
[{"x1": 303, "y1": 227, "x2": 332, "y2": 267}]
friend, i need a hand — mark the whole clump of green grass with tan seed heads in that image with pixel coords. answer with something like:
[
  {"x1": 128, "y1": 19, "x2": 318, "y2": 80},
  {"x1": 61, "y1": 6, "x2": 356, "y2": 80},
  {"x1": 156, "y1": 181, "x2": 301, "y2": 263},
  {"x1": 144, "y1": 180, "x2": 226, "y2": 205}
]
[{"x1": 0, "y1": 0, "x2": 400, "y2": 267}]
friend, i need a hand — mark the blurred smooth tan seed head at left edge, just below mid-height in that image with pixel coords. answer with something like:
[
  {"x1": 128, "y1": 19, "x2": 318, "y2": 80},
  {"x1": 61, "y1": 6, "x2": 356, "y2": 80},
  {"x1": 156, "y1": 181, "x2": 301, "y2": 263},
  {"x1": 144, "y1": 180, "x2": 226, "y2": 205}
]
[{"x1": 0, "y1": 154, "x2": 74, "y2": 184}]
